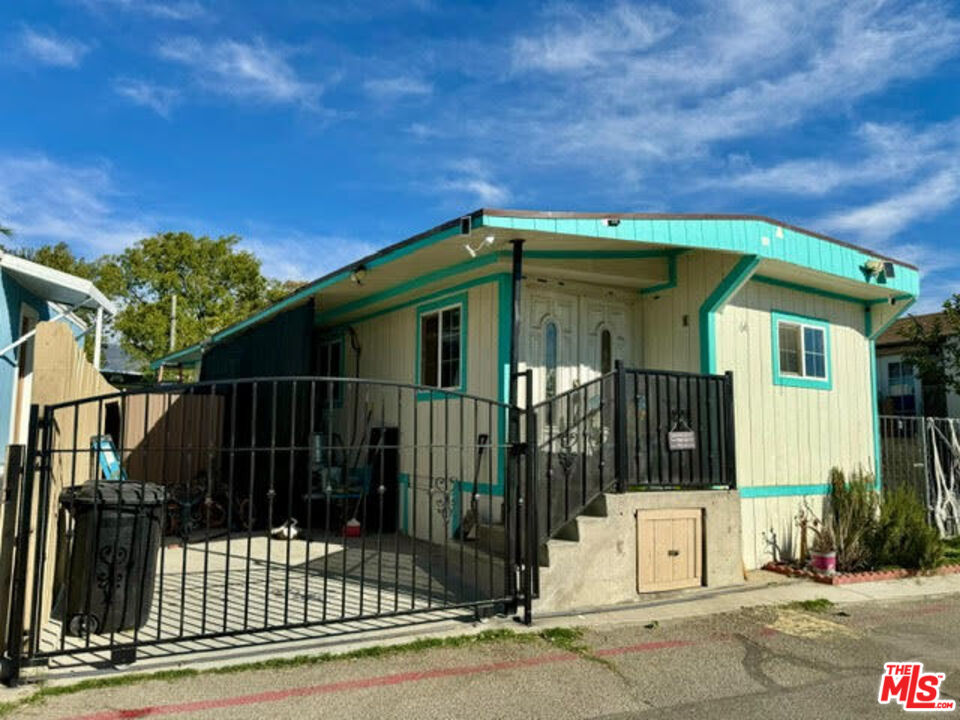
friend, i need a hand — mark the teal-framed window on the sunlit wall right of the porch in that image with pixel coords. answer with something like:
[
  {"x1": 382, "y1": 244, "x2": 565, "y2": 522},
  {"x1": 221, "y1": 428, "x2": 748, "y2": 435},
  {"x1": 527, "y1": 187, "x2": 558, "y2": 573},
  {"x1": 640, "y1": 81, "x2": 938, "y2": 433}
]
[{"x1": 771, "y1": 312, "x2": 833, "y2": 390}]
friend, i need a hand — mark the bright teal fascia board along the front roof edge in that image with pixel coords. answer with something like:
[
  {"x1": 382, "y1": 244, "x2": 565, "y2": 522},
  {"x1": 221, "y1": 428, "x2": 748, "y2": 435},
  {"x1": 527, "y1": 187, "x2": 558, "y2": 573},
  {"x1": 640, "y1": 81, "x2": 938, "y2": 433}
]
[{"x1": 482, "y1": 212, "x2": 920, "y2": 295}]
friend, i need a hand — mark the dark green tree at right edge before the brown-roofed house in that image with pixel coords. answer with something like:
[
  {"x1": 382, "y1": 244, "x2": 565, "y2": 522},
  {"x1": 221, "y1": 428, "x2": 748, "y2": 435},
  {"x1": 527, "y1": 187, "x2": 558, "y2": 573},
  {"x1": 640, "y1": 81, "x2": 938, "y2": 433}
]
[{"x1": 902, "y1": 293, "x2": 960, "y2": 416}]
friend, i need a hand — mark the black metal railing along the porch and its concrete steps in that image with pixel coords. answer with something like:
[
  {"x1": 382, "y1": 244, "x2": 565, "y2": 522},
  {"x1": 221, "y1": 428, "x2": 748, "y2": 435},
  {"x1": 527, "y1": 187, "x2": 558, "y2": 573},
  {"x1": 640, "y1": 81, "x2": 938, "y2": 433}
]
[{"x1": 534, "y1": 364, "x2": 736, "y2": 538}]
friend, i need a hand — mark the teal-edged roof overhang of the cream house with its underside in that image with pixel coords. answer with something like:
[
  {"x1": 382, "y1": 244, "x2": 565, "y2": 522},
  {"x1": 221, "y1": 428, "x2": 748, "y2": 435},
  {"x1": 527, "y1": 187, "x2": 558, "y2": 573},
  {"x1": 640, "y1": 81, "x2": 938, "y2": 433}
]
[{"x1": 152, "y1": 209, "x2": 919, "y2": 368}]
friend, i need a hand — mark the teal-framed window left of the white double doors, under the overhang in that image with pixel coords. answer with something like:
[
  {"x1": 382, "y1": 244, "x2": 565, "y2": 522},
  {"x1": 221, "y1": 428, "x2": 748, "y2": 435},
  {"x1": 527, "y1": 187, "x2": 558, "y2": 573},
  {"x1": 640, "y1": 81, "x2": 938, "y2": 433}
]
[{"x1": 417, "y1": 294, "x2": 466, "y2": 391}]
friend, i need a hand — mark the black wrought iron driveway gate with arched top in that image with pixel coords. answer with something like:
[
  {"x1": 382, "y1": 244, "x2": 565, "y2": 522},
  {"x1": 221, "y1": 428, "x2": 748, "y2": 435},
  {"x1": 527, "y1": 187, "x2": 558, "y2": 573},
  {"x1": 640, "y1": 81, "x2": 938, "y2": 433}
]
[{"x1": 4, "y1": 377, "x2": 537, "y2": 683}]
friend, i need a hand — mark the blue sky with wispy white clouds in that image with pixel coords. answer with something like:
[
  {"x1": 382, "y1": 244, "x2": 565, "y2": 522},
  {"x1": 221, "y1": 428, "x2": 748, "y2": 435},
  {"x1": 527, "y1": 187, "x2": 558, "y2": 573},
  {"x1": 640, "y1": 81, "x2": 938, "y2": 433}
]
[{"x1": 0, "y1": 0, "x2": 960, "y2": 309}]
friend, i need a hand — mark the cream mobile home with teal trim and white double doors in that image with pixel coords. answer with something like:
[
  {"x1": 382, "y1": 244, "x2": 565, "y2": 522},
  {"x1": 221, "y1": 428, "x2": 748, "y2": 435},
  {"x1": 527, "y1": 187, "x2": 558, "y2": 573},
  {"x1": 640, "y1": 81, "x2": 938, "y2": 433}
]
[{"x1": 155, "y1": 209, "x2": 919, "y2": 572}]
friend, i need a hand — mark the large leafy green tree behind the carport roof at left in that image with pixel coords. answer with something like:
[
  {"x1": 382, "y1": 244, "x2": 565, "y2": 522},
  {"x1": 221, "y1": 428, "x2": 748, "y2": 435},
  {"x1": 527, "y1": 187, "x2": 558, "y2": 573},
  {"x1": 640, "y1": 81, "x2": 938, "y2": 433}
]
[{"x1": 98, "y1": 232, "x2": 269, "y2": 365}]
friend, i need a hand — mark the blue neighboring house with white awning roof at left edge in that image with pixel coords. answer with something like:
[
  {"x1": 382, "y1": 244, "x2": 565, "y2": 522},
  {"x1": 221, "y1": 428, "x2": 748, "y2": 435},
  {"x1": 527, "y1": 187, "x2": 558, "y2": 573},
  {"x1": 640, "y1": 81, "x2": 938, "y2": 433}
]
[{"x1": 0, "y1": 253, "x2": 116, "y2": 475}]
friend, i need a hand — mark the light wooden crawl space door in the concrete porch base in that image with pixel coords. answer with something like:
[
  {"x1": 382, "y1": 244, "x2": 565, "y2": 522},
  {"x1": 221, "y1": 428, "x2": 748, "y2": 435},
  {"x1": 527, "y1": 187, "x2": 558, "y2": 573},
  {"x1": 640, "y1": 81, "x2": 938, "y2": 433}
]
[{"x1": 637, "y1": 509, "x2": 703, "y2": 593}]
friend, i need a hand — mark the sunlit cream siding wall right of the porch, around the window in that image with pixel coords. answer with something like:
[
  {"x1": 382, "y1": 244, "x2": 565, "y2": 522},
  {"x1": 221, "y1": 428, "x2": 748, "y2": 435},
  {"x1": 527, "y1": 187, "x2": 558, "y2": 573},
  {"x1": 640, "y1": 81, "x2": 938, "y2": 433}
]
[{"x1": 717, "y1": 281, "x2": 874, "y2": 567}]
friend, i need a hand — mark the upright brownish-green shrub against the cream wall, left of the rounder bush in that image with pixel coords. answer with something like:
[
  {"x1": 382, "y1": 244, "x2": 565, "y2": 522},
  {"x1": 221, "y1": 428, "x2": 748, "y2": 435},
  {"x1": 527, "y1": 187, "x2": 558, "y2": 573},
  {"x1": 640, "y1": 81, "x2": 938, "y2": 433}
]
[{"x1": 826, "y1": 468, "x2": 879, "y2": 572}]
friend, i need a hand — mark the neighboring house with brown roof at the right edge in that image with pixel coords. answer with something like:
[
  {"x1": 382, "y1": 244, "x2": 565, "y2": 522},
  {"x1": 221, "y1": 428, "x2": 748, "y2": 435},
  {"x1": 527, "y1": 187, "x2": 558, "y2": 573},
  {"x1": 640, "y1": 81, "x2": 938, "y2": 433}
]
[{"x1": 877, "y1": 313, "x2": 960, "y2": 417}]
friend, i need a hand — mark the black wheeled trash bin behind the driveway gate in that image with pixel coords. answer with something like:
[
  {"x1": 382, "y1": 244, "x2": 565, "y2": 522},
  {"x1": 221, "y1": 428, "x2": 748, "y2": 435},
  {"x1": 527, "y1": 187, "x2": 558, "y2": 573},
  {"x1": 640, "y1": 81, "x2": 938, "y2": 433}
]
[{"x1": 57, "y1": 480, "x2": 164, "y2": 636}]
